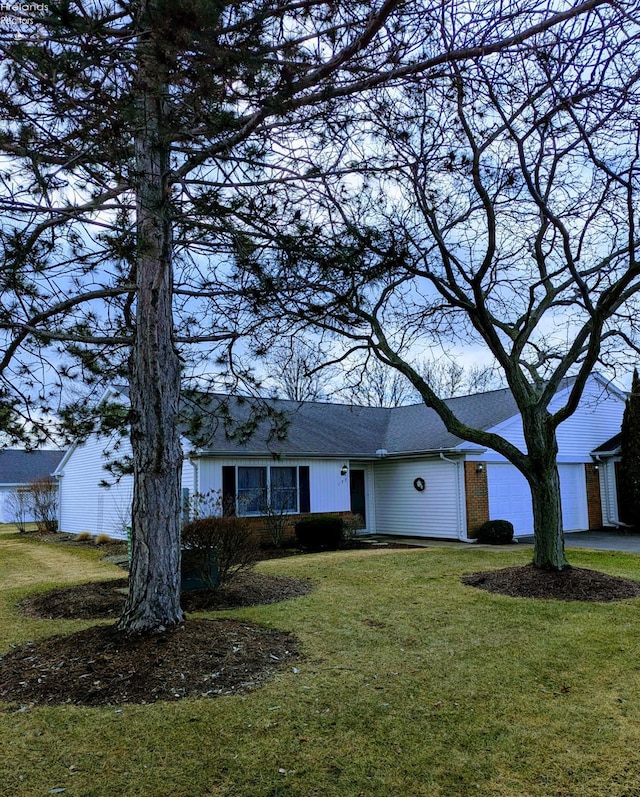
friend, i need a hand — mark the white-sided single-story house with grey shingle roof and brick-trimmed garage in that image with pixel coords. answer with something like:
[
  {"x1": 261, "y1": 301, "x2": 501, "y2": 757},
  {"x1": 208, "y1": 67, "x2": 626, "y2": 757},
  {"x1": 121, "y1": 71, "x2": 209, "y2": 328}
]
[{"x1": 56, "y1": 375, "x2": 625, "y2": 540}]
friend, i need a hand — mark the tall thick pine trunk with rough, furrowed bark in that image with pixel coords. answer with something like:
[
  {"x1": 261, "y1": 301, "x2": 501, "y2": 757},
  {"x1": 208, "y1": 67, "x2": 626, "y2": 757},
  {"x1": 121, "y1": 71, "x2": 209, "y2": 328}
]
[{"x1": 118, "y1": 4, "x2": 183, "y2": 633}]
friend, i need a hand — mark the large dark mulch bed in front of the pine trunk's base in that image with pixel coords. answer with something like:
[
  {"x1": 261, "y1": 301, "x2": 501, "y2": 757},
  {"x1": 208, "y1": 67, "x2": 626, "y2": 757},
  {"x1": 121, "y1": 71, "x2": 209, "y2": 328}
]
[{"x1": 0, "y1": 620, "x2": 298, "y2": 706}]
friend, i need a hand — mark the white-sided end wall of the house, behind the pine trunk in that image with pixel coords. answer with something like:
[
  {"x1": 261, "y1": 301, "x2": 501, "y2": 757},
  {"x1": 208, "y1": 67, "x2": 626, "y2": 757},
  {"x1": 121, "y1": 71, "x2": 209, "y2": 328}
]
[{"x1": 59, "y1": 437, "x2": 193, "y2": 539}]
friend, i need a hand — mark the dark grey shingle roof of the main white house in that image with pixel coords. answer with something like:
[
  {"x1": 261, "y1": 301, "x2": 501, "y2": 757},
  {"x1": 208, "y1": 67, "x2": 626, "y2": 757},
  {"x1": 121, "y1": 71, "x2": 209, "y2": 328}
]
[{"x1": 181, "y1": 389, "x2": 518, "y2": 456}]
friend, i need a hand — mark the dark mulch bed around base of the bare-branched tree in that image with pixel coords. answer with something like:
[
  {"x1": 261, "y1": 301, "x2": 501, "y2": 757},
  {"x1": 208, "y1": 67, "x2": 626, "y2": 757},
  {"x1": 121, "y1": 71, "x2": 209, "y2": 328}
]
[{"x1": 462, "y1": 565, "x2": 640, "y2": 602}]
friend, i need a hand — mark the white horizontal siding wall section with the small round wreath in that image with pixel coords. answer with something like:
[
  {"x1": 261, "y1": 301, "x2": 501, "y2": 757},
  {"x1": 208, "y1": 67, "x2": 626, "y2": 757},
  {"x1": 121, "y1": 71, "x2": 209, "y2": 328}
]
[{"x1": 375, "y1": 459, "x2": 464, "y2": 539}]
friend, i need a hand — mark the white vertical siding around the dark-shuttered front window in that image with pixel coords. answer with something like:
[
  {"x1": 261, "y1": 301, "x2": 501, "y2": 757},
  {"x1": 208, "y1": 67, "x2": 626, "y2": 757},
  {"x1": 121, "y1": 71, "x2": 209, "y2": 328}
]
[{"x1": 198, "y1": 457, "x2": 351, "y2": 512}]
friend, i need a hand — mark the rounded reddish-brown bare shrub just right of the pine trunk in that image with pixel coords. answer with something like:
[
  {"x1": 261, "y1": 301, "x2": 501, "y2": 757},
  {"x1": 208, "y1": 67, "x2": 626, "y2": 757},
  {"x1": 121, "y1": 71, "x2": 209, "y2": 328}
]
[{"x1": 182, "y1": 516, "x2": 259, "y2": 589}]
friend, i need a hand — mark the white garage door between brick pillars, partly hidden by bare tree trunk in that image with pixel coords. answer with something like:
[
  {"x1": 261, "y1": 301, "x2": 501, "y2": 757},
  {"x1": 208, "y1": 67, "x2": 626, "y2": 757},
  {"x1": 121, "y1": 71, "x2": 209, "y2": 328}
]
[{"x1": 487, "y1": 464, "x2": 589, "y2": 535}]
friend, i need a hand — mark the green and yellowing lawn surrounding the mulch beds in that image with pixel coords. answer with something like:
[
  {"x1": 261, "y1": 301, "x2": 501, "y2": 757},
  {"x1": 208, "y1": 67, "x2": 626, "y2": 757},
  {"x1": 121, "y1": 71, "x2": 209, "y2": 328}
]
[{"x1": 0, "y1": 524, "x2": 640, "y2": 797}]
